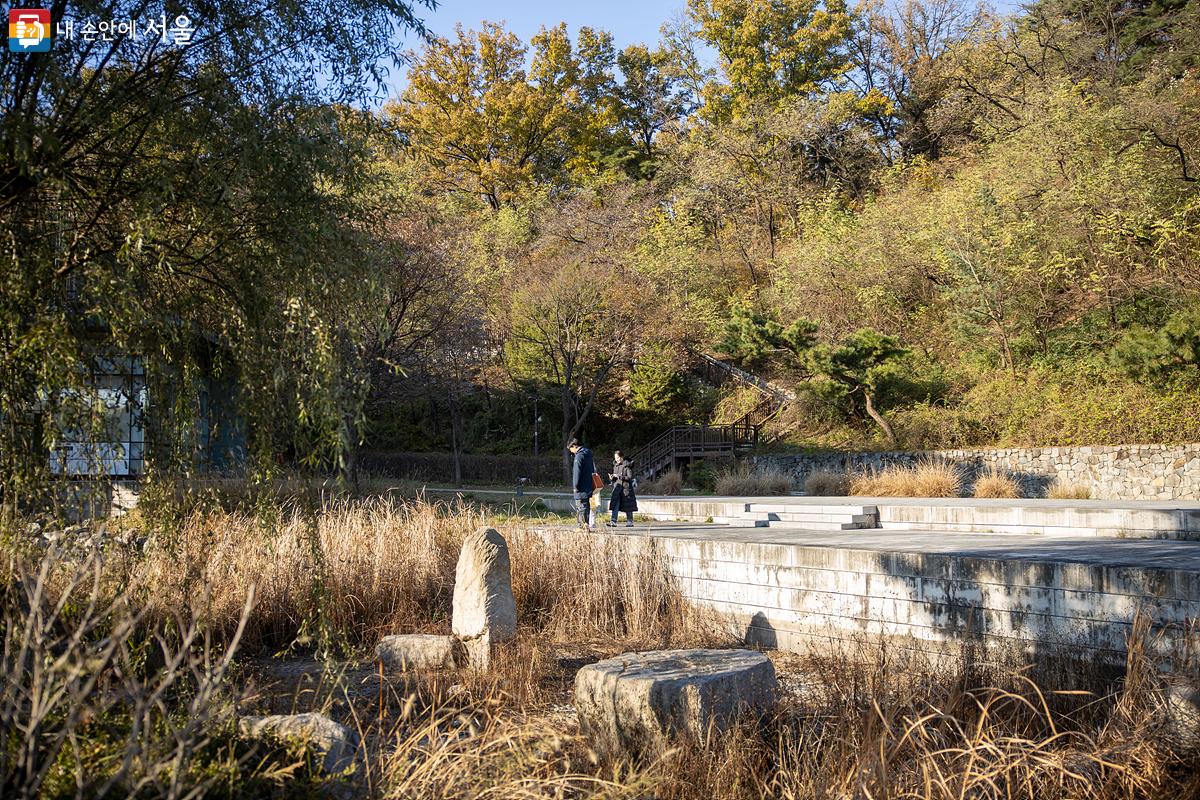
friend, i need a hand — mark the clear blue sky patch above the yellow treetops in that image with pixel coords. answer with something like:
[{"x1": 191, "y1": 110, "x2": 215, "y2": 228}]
[{"x1": 389, "y1": 0, "x2": 686, "y2": 95}]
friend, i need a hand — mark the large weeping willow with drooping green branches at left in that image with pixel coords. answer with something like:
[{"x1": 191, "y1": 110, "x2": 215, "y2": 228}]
[{"x1": 0, "y1": 0, "x2": 441, "y2": 510}]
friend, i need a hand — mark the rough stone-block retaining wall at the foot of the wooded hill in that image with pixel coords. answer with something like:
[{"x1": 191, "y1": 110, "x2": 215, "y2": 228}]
[{"x1": 752, "y1": 444, "x2": 1200, "y2": 500}]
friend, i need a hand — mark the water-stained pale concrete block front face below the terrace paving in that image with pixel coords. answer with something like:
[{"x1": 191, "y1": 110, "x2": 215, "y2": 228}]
[{"x1": 658, "y1": 537, "x2": 1200, "y2": 666}]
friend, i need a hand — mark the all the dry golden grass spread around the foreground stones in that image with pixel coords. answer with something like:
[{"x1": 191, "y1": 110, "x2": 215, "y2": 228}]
[{"x1": 0, "y1": 501, "x2": 1200, "y2": 800}]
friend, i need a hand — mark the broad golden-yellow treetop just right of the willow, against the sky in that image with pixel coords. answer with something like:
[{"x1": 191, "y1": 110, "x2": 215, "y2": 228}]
[{"x1": 385, "y1": 23, "x2": 628, "y2": 209}]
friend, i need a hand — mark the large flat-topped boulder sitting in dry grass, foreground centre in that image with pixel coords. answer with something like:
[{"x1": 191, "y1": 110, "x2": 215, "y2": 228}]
[{"x1": 575, "y1": 650, "x2": 779, "y2": 757}]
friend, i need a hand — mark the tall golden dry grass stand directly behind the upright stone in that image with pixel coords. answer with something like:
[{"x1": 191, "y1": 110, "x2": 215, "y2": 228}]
[{"x1": 128, "y1": 500, "x2": 710, "y2": 650}]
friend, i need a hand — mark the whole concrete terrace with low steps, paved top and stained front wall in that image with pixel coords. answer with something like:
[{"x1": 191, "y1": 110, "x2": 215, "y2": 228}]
[{"x1": 487, "y1": 497, "x2": 1200, "y2": 668}]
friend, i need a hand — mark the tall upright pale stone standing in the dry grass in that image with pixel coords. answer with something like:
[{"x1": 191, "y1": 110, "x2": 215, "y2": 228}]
[{"x1": 452, "y1": 528, "x2": 517, "y2": 668}]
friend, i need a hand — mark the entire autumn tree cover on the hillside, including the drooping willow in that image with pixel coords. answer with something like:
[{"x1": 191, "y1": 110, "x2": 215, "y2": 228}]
[{"x1": 0, "y1": 0, "x2": 1200, "y2": 494}]
